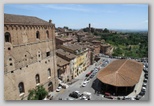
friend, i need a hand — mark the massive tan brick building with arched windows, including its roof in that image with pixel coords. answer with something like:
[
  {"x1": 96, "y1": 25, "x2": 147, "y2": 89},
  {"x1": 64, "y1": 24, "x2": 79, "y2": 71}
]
[{"x1": 4, "y1": 14, "x2": 58, "y2": 100}]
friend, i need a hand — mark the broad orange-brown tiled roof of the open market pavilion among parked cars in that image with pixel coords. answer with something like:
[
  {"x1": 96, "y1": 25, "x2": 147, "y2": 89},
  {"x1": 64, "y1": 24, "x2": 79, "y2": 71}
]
[{"x1": 97, "y1": 59, "x2": 143, "y2": 87}]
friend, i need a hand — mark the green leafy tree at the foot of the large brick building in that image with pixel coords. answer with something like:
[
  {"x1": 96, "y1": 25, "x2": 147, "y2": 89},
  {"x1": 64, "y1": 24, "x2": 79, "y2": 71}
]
[{"x1": 28, "y1": 85, "x2": 48, "y2": 100}]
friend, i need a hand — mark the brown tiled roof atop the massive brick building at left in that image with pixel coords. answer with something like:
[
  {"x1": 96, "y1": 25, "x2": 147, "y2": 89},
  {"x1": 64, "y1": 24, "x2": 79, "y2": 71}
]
[{"x1": 4, "y1": 14, "x2": 51, "y2": 25}]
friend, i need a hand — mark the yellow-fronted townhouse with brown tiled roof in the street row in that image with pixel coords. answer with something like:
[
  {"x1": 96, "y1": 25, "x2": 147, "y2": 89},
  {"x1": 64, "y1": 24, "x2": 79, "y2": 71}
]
[{"x1": 60, "y1": 43, "x2": 90, "y2": 78}]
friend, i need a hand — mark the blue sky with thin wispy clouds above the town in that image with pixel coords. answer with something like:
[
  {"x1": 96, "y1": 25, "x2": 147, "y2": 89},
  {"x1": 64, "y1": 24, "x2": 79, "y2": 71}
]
[{"x1": 4, "y1": 4, "x2": 148, "y2": 30}]
